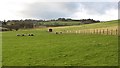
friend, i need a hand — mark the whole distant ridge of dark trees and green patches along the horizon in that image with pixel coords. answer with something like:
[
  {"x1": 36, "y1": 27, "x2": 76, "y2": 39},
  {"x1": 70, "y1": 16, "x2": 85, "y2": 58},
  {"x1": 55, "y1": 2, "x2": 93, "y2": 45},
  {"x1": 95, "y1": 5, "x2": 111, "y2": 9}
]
[{"x1": 0, "y1": 18, "x2": 100, "y2": 31}]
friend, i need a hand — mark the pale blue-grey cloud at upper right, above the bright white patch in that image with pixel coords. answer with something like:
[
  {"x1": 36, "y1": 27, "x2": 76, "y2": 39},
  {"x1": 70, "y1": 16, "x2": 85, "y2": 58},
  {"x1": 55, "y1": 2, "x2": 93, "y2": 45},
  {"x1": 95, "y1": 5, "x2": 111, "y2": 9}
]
[{"x1": 81, "y1": 2, "x2": 118, "y2": 14}]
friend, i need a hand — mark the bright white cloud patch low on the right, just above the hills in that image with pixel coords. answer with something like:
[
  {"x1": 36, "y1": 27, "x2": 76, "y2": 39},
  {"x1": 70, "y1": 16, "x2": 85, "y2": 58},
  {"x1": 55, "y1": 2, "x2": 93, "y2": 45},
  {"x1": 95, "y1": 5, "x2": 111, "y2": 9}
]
[{"x1": 71, "y1": 9, "x2": 118, "y2": 21}]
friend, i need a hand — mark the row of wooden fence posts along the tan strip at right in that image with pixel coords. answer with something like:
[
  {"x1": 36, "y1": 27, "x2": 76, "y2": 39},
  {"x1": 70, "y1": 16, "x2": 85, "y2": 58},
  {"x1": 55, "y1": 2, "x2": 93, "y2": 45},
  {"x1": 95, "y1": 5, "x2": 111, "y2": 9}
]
[{"x1": 65, "y1": 29, "x2": 119, "y2": 35}]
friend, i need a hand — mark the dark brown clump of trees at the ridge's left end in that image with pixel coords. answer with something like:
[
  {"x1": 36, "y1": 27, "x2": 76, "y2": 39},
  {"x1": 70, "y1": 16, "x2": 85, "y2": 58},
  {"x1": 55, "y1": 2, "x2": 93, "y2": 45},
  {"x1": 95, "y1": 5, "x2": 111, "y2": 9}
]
[{"x1": 2, "y1": 20, "x2": 35, "y2": 31}]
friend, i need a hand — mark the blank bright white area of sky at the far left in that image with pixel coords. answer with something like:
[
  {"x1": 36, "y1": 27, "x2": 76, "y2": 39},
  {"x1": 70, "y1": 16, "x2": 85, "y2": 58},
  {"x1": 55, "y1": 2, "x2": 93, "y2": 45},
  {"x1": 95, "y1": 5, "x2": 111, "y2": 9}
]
[{"x1": 0, "y1": 0, "x2": 37, "y2": 20}]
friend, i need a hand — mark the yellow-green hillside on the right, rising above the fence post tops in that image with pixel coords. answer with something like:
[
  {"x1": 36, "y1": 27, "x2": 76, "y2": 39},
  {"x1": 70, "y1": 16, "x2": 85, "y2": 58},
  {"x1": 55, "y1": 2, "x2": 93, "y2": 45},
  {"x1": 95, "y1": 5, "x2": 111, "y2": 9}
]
[{"x1": 50, "y1": 20, "x2": 118, "y2": 30}]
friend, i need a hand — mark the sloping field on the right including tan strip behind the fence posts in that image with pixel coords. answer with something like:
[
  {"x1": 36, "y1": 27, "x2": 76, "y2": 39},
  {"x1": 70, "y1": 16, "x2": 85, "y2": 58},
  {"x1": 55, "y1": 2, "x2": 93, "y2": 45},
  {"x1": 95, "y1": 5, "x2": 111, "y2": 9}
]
[{"x1": 50, "y1": 20, "x2": 118, "y2": 32}]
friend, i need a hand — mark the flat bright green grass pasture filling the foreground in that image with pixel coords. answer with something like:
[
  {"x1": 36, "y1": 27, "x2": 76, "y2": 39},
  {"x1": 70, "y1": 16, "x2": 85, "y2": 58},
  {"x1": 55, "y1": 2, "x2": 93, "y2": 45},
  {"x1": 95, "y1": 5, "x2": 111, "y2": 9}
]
[{"x1": 2, "y1": 20, "x2": 118, "y2": 66}]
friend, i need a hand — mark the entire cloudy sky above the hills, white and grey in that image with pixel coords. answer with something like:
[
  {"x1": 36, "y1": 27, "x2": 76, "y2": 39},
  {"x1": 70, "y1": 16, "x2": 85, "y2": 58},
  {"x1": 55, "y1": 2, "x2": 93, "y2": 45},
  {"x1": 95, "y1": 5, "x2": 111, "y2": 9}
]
[{"x1": 0, "y1": 0, "x2": 118, "y2": 21}]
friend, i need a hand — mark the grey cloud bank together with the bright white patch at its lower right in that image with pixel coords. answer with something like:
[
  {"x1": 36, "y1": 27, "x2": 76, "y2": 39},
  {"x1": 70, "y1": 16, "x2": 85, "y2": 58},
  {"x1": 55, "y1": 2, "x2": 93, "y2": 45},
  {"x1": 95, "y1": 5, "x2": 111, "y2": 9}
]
[{"x1": 20, "y1": 2, "x2": 118, "y2": 21}]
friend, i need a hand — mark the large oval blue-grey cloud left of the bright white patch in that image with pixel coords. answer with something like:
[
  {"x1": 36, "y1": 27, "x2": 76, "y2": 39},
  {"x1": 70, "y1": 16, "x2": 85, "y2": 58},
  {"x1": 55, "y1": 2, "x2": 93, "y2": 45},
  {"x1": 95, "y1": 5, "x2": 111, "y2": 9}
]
[{"x1": 22, "y1": 2, "x2": 79, "y2": 19}]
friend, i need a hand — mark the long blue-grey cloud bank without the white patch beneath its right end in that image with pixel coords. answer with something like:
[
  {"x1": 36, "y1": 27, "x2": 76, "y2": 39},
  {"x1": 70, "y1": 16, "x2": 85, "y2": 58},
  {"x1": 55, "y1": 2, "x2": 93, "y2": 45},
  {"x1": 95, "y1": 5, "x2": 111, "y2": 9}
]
[{"x1": 21, "y1": 2, "x2": 117, "y2": 19}]
